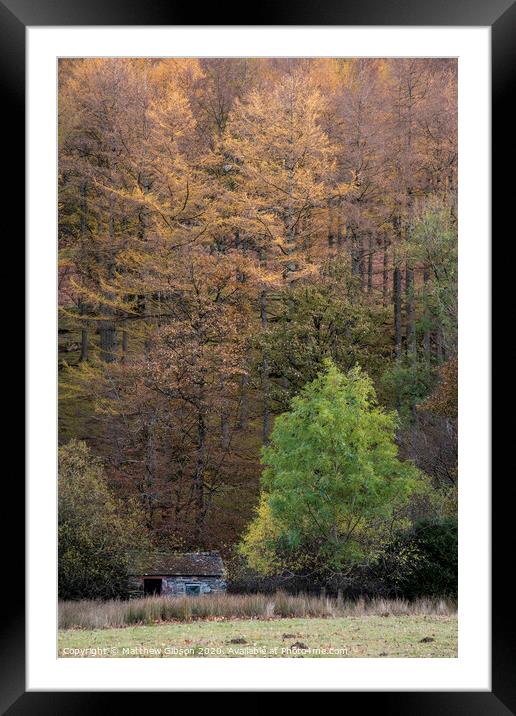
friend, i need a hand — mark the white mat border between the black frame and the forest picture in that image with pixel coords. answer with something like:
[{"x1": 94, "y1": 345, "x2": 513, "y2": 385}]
[{"x1": 27, "y1": 27, "x2": 491, "y2": 691}]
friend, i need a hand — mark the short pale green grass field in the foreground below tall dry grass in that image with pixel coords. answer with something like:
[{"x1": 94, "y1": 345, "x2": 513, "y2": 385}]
[{"x1": 58, "y1": 615, "x2": 457, "y2": 658}]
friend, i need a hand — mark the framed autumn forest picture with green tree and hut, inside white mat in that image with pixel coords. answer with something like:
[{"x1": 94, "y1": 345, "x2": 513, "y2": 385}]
[{"x1": 57, "y1": 56, "x2": 460, "y2": 660}]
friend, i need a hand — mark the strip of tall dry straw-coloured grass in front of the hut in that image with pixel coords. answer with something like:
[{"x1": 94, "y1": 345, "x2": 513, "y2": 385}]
[{"x1": 59, "y1": 592, "x2": 457, "y2": 629}]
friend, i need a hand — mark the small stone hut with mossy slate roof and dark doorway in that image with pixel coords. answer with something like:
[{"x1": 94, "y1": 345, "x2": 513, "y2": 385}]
[{"x1": 128, "y1": 552, "x2": 226, "y2": 597}]
